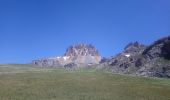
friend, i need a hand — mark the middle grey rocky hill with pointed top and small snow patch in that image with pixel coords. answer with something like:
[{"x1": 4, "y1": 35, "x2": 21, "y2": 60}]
[{"x1": 101, "y1": 42, "x2": 146, "y2": 73}]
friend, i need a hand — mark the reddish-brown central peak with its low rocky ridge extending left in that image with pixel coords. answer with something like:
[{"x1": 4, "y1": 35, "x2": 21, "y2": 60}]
[{"x1": 32, "y1": 44, "x2": 101, "y2": 68}]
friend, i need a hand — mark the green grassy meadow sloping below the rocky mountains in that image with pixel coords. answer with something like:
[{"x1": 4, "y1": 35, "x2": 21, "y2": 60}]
[{"x1": 0, "y1": 65, "x2": 170, "y2": 100}]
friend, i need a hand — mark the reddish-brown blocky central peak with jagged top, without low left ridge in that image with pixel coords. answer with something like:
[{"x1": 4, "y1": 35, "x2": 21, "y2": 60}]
[{"x1": 65, "y1": 44, "x2": 101, "y2": 65}]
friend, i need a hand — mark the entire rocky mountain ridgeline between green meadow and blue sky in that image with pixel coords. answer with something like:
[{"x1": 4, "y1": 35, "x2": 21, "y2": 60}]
[{"x1": 32, "y1": 36, "x2": 170, "y2": 78}]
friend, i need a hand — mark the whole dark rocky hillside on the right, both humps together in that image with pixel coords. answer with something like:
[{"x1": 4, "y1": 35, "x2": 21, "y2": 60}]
[{"x1": 99, "y1": 36, "x2": 170, "y2": 78}]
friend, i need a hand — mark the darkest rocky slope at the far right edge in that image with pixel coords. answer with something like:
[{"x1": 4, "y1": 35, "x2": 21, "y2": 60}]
[{"x1": 136, "y1": 36, "x2": 170, "y2": 78}]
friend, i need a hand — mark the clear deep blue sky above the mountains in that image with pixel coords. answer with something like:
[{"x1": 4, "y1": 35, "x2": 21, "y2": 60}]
[{"x1": 0, "y1": 0, "x2": 170, "y2": 63}]
